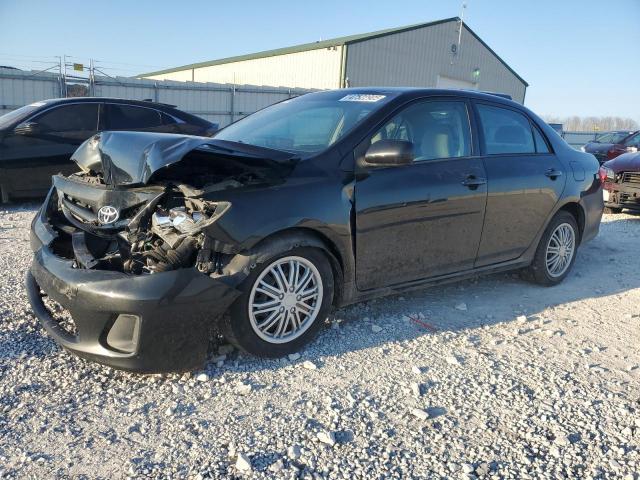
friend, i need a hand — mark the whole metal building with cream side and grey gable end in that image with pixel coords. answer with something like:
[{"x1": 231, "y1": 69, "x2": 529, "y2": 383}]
[{"x1": 139, "y1": 17, "x2": 528, "y2": 103}]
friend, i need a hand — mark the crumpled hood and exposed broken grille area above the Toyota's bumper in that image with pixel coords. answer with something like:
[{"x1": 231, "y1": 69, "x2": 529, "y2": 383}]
[{"x1": 46, "y1": 132, "x2": 298, "y2": 275}]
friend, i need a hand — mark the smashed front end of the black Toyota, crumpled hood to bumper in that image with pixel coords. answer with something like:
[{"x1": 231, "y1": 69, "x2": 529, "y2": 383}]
[{"x1": 27, "y1": 132, "x2": 286, "y2": 372}]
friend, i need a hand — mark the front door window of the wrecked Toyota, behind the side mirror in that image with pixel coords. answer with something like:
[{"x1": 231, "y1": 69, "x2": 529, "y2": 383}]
[{"x1": 371, "y1": 101, "x2": 471, "y2": 161}]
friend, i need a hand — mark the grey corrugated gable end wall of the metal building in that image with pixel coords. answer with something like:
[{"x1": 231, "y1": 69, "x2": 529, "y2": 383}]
[{"x1": 346, "y1": 21, "x2": 525, "y2": 103}]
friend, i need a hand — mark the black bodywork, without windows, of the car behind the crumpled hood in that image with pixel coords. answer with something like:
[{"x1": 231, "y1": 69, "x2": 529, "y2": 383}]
[{"x1": 0, "y1": 97, "x2": 217, "y2": 201}]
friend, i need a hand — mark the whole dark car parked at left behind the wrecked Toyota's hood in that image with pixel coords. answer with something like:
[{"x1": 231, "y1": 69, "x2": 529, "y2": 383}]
[{"x1": 0, "y1": 97, "x2": 217, "y2": 202}]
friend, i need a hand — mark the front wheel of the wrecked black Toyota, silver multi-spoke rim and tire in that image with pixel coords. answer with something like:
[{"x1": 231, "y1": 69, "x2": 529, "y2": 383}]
[{"x1": 220, "y1": 247, "x2": 334, "y2": 358}]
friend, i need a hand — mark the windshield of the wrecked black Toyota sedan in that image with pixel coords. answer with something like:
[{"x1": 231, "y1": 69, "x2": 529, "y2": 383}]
[{"x1": 214, "y1": 94, "x2": 390, "y2": 156}]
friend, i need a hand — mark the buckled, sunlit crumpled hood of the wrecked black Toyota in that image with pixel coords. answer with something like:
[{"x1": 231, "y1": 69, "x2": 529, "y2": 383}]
[{"x1": 71, "y1": 132, "x2": 216, "y2": 185}]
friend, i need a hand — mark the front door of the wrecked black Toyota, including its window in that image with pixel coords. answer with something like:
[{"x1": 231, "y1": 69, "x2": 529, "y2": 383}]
[{"x1": 355, "y1": 100, "x2": 487, "y2": 290}]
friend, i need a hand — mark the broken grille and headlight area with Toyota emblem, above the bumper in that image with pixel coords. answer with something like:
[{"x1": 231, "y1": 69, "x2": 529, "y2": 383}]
[{"x1": 49, "y1": 174, "x2": 231, "y2": 275}]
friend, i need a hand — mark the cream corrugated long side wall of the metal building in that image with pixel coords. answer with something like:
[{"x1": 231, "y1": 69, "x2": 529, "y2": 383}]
[{"x1": 147, "y1": 46, "x2": 343, "y2": 89}]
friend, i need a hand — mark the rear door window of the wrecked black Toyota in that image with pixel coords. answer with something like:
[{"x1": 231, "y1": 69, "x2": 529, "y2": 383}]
[{"x1": 478, "y1": 104, "x2": 536, "y2": 155}]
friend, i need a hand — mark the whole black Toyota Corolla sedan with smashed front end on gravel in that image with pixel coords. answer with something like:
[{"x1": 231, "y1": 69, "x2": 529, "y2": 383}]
[{"x1": 26, "y1": 88, "x2": 603, "y2": 372}]
